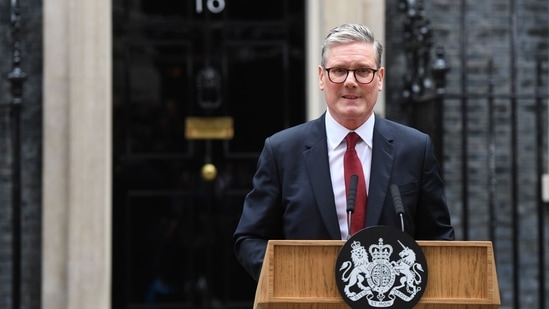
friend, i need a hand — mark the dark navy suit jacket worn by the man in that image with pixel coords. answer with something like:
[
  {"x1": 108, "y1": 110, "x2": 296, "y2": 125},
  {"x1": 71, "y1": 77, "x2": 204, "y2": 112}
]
[{"x1": 234, "y1": 114, "x2": 455, "y2": 280}]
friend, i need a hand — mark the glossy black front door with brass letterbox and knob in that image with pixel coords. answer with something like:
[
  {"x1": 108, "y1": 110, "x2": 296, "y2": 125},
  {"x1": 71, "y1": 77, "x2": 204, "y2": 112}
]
[{"x1": 112, "y1": 0, "x2": 305, "y2": 309}]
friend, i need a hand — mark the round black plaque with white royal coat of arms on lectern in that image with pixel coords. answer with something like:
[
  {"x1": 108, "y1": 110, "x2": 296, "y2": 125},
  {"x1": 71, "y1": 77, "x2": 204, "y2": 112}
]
[{"x1": 336, "y1": 226, "x2": 427, "y2": 309}]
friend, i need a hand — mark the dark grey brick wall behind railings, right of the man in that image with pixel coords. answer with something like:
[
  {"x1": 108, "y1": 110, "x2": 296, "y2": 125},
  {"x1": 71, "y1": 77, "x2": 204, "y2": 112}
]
[{"x1": 386, "y1": 0, "x2": 549, "y2": 308}]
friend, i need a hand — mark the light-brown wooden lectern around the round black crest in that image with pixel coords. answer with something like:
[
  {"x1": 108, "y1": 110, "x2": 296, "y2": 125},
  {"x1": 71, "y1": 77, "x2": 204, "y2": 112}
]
[{"x1": 254, "y1": 240, "x2": 501, "y2": 309}]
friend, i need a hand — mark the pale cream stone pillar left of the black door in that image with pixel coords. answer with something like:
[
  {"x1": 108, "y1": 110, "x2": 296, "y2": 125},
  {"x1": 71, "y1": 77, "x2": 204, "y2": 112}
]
[{"x1": 41, "y1": 0, "x2": 112, "y2": 309}]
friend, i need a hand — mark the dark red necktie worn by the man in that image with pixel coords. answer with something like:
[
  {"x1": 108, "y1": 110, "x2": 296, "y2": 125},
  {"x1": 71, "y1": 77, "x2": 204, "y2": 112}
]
[{"x1": 343, "y1": 132, "x2": 368, "y2": 235}]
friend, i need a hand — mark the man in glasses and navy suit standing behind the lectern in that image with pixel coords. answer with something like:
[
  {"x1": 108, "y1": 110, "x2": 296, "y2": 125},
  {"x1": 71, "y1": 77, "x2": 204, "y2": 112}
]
[{"x1": 234, "y1": 24, "x2": 455, "y2": 280}]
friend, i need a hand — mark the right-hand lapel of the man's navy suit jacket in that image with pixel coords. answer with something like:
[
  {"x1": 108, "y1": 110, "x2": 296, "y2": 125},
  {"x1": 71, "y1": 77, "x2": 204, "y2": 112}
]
[{"x1": 366, "y1": 117, "x2": 394, "y2": 226}]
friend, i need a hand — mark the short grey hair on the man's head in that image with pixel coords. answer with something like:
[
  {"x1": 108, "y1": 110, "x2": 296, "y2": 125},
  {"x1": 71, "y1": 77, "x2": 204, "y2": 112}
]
[{"x1": 320, "y1": 24, "x2": 383, "y2": 69}]
